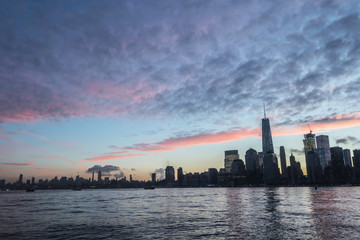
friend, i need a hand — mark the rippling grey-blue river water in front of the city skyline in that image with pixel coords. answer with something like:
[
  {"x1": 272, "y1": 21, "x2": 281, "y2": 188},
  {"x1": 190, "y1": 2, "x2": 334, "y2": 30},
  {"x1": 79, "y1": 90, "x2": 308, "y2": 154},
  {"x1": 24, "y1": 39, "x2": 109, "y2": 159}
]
[{"x1": 0, "y1": 187, "x2": 360, "y2": 239}]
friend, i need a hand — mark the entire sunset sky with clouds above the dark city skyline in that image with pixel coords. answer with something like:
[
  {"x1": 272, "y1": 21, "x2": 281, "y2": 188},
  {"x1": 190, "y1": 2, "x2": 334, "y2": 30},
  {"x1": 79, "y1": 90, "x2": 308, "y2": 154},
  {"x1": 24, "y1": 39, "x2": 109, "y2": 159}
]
[{"x1": 0, "y1": 0, "x2": 360, "y2": 182}]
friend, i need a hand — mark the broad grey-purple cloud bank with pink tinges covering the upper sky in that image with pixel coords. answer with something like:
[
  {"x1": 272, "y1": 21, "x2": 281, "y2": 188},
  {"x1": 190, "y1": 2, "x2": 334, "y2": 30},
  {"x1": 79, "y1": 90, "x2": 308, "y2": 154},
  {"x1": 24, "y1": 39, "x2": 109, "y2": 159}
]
[{"x1": 0, "y1": 0, "x2": 360, "y2": 127}]
